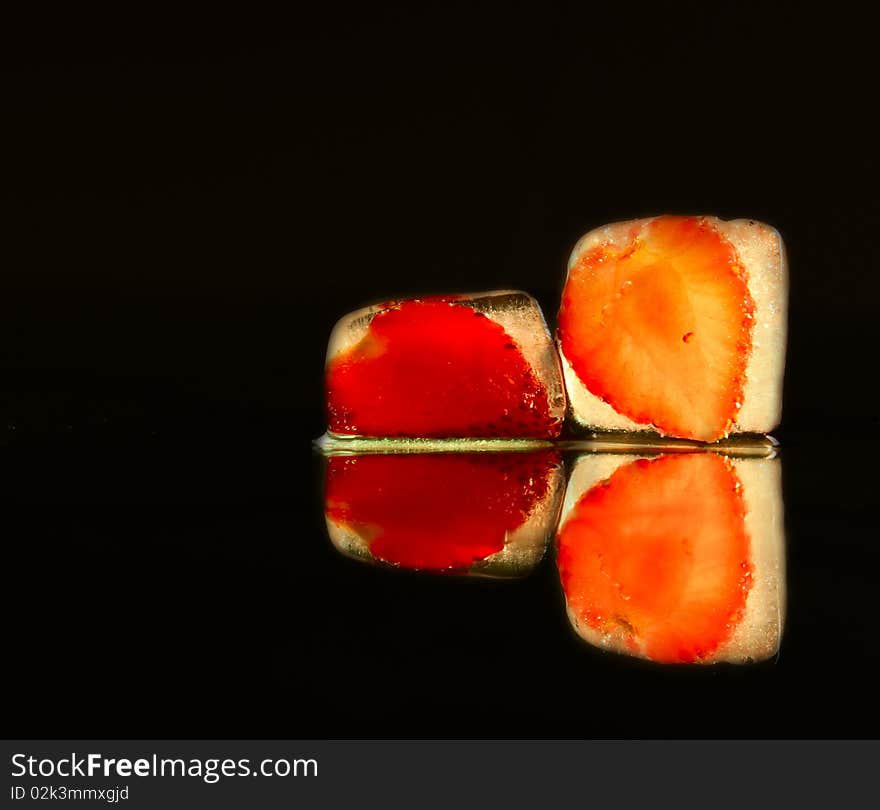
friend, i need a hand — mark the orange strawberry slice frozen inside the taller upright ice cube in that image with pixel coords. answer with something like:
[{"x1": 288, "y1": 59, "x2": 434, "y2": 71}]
[{"x1": 559, "y1": 216, "x2": 754, "y2": 441}]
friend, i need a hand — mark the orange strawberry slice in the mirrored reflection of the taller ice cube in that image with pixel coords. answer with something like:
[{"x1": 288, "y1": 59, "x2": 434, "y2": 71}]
[{"x1": 558, "y1": 454, "x2": 752, "y2": 663}]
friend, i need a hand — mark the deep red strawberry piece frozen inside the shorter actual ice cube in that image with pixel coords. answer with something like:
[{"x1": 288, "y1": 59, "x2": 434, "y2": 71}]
[{"x1": 327, "y1": 299, "x2": 562, "y2": 438}]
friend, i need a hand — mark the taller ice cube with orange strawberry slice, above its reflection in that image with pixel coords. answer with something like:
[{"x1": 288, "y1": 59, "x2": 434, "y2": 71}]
[{"x1": 558, "y1": 216, "x2": 788, "y2": 442}]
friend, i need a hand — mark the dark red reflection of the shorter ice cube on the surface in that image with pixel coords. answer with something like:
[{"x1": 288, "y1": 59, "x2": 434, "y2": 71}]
[{"x1": 325, "y1": 451, "x2": 565, "y2": 577}]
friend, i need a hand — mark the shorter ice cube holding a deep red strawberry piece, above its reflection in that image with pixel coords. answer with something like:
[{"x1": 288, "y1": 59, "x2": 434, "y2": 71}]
[{"x1": 326, "y1": 290, "x2": 565, "y2": 438}]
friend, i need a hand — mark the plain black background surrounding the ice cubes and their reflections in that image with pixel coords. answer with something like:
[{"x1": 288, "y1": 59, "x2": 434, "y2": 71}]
[{"x1": 0, "y1": 3, "x2": 880, "y2": 737}]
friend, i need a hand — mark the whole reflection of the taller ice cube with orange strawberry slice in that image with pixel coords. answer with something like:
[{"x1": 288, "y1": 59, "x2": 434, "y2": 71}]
[{"x1": 557, "y1": 453, "x2": 785, "y2": 664}]
